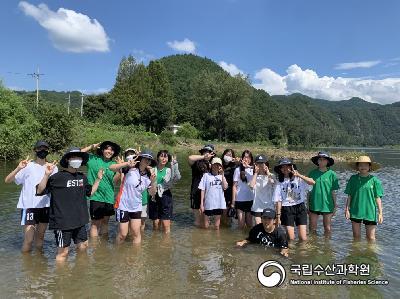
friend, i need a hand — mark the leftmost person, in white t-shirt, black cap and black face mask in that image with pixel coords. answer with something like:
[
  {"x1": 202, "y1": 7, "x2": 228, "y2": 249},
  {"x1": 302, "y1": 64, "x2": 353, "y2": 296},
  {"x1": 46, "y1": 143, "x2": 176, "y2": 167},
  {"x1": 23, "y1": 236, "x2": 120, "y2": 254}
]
[{"x1": 4, "y1": 141, "x2": 58, "y2": 252}]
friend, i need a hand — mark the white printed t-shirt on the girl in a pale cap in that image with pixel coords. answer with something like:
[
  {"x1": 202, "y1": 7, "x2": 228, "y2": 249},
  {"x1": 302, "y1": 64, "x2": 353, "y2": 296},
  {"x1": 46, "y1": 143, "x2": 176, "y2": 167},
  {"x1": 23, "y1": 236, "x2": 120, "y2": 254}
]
[{"x1": 199, "y1": 173, "x2": 226, "y2": 210}]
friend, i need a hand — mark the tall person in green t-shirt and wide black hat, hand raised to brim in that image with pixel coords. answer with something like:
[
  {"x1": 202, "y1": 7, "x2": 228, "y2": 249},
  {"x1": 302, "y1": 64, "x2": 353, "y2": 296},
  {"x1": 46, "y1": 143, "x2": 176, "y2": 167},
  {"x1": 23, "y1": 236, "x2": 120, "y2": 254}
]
[{"x1": 81, "y1": 141, "x2": 121, "y2": 238}]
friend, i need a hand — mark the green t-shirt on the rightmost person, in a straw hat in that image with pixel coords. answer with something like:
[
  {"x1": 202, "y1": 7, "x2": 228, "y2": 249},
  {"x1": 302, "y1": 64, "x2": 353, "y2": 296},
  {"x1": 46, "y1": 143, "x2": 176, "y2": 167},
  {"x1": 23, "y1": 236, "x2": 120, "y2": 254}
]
[{"x1": 344, "y1": 174, "x2": 383, "y2": 222}]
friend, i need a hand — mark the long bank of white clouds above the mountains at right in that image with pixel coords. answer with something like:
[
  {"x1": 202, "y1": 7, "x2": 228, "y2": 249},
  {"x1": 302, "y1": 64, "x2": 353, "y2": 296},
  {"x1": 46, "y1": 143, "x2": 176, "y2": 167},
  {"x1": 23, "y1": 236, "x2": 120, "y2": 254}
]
[{"x1": 253, "y1": 64, "x2": 400, "y2": 104}]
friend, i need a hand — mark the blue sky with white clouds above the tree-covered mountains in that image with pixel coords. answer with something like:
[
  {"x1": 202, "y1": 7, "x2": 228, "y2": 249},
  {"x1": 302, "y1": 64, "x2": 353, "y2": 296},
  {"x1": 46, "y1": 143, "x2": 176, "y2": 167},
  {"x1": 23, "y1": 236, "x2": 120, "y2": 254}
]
[{"x1": 0, "y1": 0, "x2": 400, "y2": 104}]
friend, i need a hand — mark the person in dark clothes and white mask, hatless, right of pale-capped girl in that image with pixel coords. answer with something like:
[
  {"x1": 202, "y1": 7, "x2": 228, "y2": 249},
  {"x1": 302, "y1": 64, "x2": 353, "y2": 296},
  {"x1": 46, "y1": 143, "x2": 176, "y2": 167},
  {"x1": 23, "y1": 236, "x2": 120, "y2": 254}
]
[{"x1": 221, "y1": 148, "x2": 240, "y2": 225}]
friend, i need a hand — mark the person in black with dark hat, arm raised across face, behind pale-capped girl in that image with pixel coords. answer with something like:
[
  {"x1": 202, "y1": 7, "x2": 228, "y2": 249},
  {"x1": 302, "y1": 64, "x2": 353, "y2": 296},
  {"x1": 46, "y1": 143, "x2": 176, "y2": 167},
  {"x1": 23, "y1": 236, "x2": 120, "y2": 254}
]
[{"x1": 188, "y1": 144, "x2": 215, "y2": 226}]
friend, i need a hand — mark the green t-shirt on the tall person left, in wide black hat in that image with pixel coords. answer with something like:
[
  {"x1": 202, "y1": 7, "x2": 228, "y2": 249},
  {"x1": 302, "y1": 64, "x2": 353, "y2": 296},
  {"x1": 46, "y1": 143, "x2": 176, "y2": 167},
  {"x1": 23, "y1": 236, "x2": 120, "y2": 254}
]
[{"x1": 87, "y1": 154, "x2": 116, "y2": 204}]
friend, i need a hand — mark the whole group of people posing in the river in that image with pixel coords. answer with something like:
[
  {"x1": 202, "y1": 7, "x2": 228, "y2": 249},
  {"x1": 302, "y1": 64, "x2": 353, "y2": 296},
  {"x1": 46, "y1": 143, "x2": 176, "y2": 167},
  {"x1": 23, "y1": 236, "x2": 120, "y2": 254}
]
[{"x1": 5, "y1": 141, "x2": 383, "y2": 261}]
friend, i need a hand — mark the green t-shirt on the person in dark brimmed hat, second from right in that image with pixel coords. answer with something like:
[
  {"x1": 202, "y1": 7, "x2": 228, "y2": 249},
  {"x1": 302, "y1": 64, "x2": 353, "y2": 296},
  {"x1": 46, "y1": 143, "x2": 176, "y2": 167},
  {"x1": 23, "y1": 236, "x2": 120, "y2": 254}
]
[{"x1": 308, "y1": 168, "x2": 339, "y2": 213}]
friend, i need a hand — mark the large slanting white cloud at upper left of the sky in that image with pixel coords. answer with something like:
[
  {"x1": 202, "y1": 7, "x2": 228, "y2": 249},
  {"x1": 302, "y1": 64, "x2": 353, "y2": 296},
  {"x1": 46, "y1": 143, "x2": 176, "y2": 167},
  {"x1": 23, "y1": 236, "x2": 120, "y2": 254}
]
[{"x1": 18, "y1": 1, "x2": 110, "y2": 53}]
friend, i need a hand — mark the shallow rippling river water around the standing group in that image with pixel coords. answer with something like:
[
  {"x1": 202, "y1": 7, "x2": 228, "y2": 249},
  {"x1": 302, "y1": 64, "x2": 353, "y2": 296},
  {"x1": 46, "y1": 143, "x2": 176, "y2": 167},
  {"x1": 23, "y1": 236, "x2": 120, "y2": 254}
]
[{"x1": 0, "y1": 149, "x2": 400, "y2": 298}]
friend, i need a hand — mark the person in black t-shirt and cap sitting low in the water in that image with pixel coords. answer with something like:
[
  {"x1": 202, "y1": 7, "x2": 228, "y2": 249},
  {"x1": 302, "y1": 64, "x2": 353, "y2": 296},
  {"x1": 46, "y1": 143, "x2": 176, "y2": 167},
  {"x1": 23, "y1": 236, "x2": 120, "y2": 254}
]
[{"x1": 236, "y1": 209, "x2": 289, "y2": 257}]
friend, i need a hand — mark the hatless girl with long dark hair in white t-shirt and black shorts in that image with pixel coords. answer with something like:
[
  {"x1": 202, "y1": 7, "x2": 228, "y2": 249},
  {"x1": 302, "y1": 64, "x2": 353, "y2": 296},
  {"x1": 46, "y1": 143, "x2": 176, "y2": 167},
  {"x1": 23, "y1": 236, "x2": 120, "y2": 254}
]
[{"x1": 231, "y1": 150, "x2": 254, "y2": 229}]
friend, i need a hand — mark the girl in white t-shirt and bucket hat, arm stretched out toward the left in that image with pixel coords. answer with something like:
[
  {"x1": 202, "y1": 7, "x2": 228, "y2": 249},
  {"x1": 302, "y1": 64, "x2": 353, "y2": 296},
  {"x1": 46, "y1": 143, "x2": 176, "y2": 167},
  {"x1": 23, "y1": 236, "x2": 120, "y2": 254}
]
[{"x1": 110, "y1": 151, "x2": 157, "y2": 244}]
